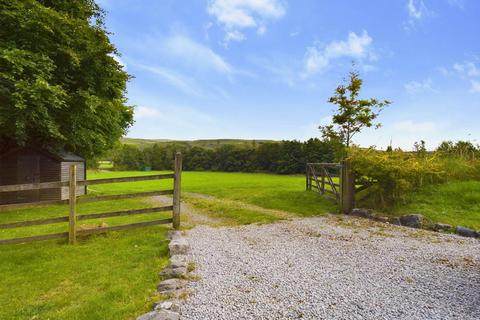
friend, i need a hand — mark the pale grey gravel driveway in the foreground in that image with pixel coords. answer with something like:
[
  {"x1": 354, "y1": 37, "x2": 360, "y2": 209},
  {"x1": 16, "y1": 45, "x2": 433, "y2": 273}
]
[{"x1": 181, "y1": 216, "x2": 480, "y2": 320}]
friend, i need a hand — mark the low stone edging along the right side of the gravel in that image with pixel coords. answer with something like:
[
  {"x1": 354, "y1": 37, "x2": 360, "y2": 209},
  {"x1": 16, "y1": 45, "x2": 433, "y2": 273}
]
[{"x1": 350, "y1": 208, "x2": 480, "y2": 238}]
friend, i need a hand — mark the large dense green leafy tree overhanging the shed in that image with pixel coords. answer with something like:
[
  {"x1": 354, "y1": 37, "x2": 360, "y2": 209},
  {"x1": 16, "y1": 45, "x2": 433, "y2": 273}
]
[{"x1": 0, "y1": 0, "x2": 133, "y2": 157}]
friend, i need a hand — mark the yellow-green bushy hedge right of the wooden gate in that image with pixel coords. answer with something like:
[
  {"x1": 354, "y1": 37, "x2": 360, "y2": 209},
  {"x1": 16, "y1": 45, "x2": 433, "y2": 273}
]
[{"x1": 349, "y1": 148, "x2": 480, "y2": 208}]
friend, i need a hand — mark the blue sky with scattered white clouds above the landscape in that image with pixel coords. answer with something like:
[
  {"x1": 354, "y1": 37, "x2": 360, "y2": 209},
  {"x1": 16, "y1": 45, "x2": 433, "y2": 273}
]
[{"x1": 99, "y1": 0, "x2": 480, "y2": 149}]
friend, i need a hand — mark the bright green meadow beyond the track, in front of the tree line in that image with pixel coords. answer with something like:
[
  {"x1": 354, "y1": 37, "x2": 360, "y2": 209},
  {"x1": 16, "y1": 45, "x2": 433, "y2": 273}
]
[{"x1": 89, "y1": 171, "x2": 337, "y2": 222}]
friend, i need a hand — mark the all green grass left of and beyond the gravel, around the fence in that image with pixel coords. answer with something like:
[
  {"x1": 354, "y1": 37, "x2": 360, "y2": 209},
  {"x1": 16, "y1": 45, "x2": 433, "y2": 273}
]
[{"x1": 0, "y1": 171, "x2": 336, "y2": 319}]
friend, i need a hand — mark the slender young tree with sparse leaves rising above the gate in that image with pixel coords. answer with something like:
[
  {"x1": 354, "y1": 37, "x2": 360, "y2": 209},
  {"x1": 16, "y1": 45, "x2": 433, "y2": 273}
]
[{"x1": 319, "y1": 71, "x2": 391, "y2": 148}]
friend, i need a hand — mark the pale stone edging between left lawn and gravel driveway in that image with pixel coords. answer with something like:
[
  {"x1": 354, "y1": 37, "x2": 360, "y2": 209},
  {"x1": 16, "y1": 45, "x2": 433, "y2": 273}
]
[{"x1": 137, "y1": 231, "x2": 193, "y2": 320}]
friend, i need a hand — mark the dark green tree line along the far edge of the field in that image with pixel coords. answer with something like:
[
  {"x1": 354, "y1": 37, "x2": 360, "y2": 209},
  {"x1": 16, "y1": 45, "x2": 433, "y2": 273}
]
[{"x1": 112, "y1": 138, "x2": 338, "y2": 174}]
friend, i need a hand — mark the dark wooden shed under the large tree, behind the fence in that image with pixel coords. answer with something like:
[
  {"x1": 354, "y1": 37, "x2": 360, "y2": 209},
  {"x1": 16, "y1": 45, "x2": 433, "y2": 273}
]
[{"x1": 0, "y1": 147, "x2": 86, "y2": 204}]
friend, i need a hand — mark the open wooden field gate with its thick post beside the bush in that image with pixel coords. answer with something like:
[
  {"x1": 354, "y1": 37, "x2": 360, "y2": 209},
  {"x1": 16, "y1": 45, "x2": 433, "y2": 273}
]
[{"x1": 306, "y1": 161, "x2": 362, "y2": 214}]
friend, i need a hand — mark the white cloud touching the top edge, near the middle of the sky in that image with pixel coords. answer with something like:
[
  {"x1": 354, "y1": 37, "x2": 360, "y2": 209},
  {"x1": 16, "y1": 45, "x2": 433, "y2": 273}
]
[{"x1": 207, "y1": 0, "x2": 286, "y2": 41}]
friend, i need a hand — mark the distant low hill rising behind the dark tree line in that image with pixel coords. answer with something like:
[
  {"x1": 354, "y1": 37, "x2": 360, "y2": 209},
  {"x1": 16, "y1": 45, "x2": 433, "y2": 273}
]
[{"x1": 121, "y1": 138, "x2": 276, "y2": 149}]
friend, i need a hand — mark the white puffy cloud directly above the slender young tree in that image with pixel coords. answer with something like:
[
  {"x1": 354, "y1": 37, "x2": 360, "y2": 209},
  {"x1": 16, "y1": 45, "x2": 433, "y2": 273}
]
[{"x1": 302, "y1": 30, "x2": 376, "y2": 78}]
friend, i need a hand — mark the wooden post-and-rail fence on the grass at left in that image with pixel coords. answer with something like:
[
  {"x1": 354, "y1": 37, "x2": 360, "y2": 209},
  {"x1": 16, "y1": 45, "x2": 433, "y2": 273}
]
[{"x1": 0, "y1": 152, "x2": 182, "y2": 245}]
